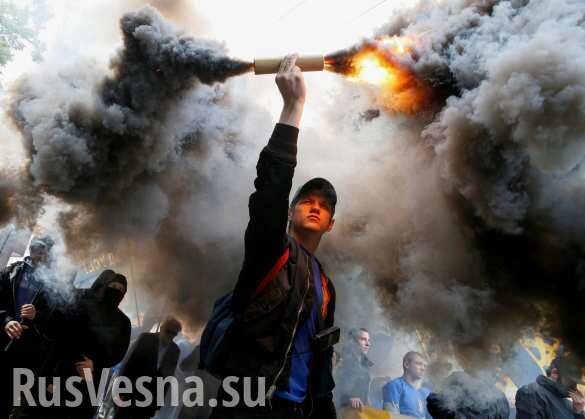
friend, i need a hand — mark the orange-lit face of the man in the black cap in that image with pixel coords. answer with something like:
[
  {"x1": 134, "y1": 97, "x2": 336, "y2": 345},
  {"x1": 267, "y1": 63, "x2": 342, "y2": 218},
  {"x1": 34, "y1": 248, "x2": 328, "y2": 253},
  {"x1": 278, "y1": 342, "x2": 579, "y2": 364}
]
[{"x1": 290, "y1": 192, "x2": 335, "y2": 234}]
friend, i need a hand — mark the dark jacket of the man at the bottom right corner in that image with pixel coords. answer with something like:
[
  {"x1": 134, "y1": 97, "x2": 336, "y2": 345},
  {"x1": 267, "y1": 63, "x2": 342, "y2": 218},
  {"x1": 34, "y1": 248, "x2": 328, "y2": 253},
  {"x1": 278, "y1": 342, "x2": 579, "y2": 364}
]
[{"x1": 516, "y1": 375, "x2": 585, "y2": 419}]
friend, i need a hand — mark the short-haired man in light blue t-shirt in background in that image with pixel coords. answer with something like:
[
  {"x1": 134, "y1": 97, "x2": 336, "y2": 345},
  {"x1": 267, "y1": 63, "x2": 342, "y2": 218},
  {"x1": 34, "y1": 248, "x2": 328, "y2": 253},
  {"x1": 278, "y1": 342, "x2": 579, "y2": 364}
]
[{"x1": 382, "y1": 351, "x2": 431, "y2": 418}]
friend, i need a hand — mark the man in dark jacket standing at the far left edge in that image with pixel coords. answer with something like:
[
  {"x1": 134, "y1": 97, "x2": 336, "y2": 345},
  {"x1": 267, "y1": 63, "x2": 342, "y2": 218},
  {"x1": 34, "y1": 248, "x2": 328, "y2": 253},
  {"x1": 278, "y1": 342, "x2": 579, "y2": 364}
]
[{"x1": 0, "y1": 237, "x2": 53, "y2": 419}]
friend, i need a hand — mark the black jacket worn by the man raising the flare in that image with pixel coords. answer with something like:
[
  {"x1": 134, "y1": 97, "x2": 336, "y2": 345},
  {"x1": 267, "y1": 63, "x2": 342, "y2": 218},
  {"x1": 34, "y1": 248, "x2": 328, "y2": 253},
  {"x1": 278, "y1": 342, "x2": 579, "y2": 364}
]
[{"x1": 227, "y1": 124, "x2": 335, "y2": 418}]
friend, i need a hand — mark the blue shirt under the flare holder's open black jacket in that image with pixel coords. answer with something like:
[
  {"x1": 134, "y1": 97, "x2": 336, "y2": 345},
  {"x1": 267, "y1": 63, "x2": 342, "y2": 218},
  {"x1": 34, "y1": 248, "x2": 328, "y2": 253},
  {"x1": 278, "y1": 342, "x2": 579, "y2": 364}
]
[{"x1": 274, "y1": 256, "x2": 323, "y2": 403}]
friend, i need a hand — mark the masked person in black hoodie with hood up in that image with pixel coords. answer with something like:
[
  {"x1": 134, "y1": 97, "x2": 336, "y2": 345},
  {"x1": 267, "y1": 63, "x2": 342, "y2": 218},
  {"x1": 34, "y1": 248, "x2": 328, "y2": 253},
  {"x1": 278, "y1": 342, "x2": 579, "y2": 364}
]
[{"x1": 47, "y1": 270, "x2": 131, "y2": 419}]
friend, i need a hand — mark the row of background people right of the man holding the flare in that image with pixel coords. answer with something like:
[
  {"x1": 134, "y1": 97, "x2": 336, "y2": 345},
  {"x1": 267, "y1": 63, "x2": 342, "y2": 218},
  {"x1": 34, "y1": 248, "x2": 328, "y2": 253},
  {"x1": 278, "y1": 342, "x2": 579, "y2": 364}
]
[{"x1": 335, "y1": 328, "x2": 585, "y2": 419}]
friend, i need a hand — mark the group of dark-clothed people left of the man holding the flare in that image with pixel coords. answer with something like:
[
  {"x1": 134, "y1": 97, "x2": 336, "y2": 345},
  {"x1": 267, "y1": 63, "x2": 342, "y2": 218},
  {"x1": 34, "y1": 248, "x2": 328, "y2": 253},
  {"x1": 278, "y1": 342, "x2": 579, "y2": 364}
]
[{"x1": 0, "y1": 237, "x2": 187, "y2": 419}]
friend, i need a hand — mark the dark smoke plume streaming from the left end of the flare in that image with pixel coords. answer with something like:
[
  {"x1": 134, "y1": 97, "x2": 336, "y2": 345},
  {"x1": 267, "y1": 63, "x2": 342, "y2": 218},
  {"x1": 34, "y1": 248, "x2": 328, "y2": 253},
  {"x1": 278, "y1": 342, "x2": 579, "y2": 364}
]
[{"x1": 12, "y1": 7, "x2": 248, "y2": 208}]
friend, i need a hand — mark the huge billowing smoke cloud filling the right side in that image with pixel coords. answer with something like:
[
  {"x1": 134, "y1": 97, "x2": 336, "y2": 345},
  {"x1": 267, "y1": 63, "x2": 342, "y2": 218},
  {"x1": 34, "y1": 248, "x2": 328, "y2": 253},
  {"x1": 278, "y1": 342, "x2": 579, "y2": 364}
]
[{"x1": 320, "y1": 0, "x2": 585, "y2": 368}]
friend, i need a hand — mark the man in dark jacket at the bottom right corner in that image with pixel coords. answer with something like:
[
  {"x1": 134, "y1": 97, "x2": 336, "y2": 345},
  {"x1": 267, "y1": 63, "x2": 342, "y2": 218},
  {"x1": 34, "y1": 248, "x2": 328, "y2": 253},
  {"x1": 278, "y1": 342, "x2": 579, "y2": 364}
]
[{"x1": 516, "y1": 355, "x2": 585, "y2": 419}]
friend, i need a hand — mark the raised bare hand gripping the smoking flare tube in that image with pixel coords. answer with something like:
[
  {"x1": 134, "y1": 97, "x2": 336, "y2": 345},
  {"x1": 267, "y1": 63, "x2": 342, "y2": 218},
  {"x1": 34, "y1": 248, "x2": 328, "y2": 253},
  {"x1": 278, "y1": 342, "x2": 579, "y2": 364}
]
[{"x1": 276, "y1": 54, "x2": 307, "y2": 128}]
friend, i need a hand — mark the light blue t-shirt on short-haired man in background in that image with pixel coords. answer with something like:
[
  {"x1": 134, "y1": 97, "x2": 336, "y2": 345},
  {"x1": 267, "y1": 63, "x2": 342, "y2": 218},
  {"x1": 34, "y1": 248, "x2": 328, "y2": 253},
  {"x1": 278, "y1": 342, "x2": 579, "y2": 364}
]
[{"x1": 382, "y1": 377, "x2": 432, "y2": 419}]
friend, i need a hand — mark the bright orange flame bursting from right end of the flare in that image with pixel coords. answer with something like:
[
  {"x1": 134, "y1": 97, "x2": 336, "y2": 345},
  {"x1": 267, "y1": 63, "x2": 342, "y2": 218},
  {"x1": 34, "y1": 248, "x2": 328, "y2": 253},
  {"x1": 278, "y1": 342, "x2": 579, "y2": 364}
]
[{"x1": 325, "y1": 36, "x2": 431, "y2": 114}]
